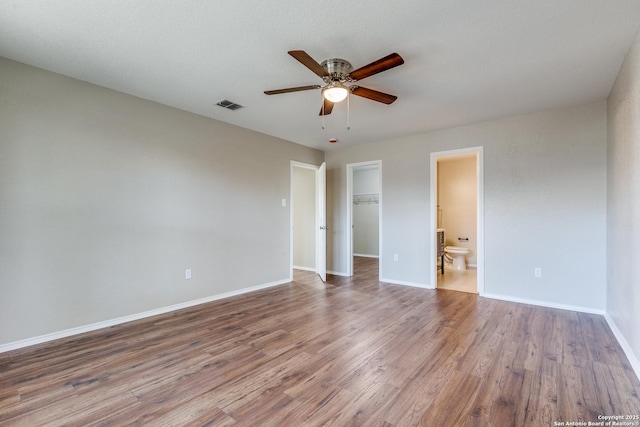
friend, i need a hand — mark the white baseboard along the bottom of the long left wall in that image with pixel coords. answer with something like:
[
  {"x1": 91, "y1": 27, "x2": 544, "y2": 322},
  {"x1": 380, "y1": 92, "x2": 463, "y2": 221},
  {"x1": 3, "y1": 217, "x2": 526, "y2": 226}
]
[{"x1": 0, "y1": 279, "x2": 291, "y2": 353}]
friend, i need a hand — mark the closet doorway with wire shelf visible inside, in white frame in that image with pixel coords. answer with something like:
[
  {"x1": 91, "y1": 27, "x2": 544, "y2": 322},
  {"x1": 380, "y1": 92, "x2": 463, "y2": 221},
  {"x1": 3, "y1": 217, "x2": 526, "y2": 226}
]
[{"x1": 346, "y1": 160, "x2": 382, "y2": 277}]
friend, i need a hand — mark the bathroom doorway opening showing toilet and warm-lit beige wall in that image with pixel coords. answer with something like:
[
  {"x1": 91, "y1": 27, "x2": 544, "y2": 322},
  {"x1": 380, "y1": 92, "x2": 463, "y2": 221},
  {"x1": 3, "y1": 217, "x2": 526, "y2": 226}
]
[{"x1": 431, "y1": 147, "x2": 484, "y2": 295}]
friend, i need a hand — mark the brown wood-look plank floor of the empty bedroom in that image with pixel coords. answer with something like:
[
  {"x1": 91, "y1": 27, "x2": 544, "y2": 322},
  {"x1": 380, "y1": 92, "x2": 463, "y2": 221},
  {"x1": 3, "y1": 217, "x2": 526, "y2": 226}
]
[{"x1": 0, "y1": 258, "x2": 640, "y2": 427}]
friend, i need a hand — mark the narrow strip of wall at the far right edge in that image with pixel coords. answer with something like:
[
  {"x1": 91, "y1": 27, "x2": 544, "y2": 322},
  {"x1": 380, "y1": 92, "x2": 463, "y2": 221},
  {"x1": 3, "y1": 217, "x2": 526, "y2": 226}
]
[{"x1": 607, "y1": 30, "x2": 640, "y2": 372}]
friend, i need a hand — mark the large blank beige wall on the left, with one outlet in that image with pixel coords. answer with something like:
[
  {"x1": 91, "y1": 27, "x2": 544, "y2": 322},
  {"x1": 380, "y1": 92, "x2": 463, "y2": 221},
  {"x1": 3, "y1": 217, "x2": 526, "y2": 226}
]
[{"x1": 0, "y1": 59, "x2": 324, "y2": 344}]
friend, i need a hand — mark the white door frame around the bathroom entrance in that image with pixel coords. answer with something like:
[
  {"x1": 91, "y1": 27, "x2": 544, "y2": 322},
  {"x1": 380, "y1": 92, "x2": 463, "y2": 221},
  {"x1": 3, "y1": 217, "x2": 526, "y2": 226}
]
[{"x1": 429, "y1": 146, "x2": 484, "y2": 296}]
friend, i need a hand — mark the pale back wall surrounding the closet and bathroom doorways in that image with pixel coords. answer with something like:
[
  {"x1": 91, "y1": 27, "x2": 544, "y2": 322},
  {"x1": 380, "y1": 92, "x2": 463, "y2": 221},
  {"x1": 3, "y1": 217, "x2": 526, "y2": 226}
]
[{"x1": 326, "y1": 101, "x2": 607, "y2": 311}]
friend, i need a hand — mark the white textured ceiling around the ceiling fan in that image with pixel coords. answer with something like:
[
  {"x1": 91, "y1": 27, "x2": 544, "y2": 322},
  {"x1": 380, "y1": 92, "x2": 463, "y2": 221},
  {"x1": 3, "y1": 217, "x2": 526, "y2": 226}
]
[{"x1": 0, "y1": 0, "x2": 640, "y2": 150}]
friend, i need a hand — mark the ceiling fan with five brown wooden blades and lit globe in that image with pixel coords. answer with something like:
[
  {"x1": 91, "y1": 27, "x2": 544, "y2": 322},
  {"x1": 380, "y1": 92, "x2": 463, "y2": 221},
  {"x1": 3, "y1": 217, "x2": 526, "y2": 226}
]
[{"x1": 264, "y1": 50, "x2": 404, "y2": 116}]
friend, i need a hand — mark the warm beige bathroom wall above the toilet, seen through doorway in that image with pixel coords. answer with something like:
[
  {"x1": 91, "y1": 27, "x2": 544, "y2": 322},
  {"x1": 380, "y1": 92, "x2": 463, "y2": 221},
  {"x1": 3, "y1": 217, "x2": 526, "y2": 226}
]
[{"x1": 438, "y1": 155, "x2": 478, "y2": 266}]
